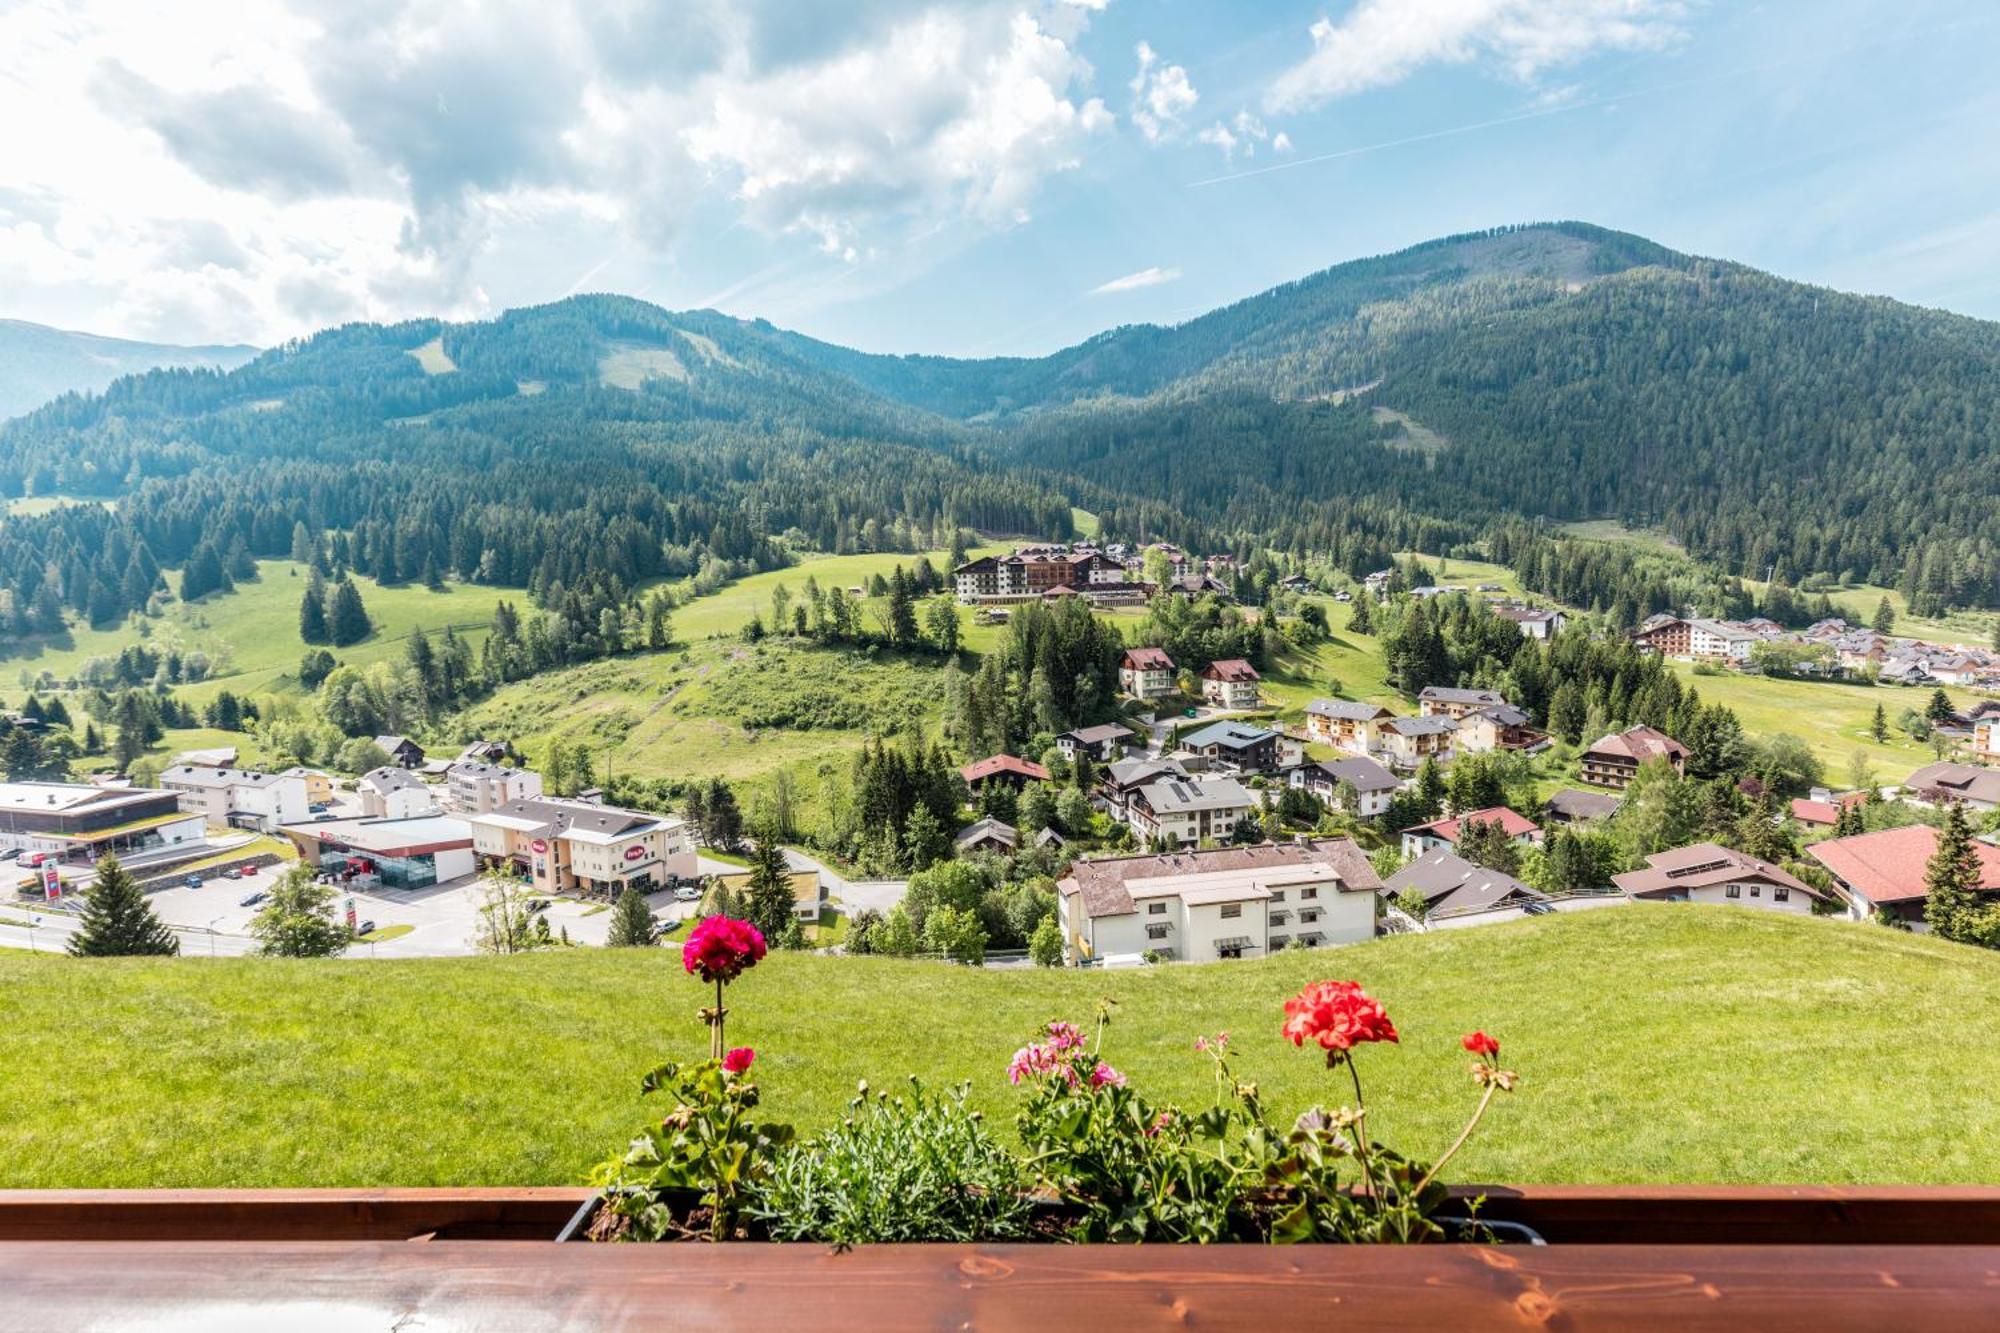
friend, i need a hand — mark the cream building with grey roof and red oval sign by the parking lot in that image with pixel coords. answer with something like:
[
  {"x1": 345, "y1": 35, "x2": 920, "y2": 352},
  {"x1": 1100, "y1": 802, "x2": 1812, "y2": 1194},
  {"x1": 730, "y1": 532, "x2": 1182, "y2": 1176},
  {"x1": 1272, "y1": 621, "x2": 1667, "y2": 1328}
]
[{"x1": 466, "y1": 797, "x2": 696, "y2": 897}]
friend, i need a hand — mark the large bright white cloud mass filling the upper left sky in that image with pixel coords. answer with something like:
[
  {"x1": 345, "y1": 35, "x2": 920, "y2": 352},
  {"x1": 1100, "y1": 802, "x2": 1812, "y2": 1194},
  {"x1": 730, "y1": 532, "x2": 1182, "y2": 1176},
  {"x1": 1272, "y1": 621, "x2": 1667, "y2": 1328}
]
[{"x1": 0, "y1": 0, "x2": 1114, "y2": 340}]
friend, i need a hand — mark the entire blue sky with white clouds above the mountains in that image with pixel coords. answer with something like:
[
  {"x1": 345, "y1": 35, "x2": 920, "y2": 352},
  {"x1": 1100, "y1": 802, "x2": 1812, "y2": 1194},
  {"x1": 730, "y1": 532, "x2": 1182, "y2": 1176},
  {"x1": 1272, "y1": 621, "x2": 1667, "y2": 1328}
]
[{"x1": 0, "y1": 0, "x2": 2000, "y2": 356}]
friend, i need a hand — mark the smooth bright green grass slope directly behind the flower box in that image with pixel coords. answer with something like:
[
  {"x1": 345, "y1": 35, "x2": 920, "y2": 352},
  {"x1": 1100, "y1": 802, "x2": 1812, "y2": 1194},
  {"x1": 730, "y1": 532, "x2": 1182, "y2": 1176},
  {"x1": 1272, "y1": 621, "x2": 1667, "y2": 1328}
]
[{"x1": 0, "y1": 907, "x2": 2000, "y2": 1187}]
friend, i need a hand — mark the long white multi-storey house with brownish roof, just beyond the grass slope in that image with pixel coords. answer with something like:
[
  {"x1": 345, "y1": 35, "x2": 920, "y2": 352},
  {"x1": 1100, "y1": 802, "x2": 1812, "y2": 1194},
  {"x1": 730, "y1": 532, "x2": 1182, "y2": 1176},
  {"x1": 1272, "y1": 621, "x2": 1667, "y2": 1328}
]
[{"x1": 1056, "y1": 839, "x2": 1382, "y2": 963}]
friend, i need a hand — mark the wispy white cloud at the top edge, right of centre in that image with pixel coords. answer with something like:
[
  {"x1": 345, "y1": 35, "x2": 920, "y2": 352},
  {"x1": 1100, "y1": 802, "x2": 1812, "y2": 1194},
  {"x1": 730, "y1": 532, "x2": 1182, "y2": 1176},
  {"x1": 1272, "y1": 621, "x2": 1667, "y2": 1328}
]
[{"x1": 1264, "y1": 0, "x2": 1688, "y2": 112}]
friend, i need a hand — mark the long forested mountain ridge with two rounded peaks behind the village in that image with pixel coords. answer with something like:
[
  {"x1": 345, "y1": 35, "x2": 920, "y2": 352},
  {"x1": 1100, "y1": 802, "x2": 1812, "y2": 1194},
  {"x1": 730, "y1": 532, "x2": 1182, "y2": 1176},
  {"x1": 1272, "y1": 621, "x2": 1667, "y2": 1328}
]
[{"x1": 0, "y1": 222, "x2": 2000, "y2": 644}]
